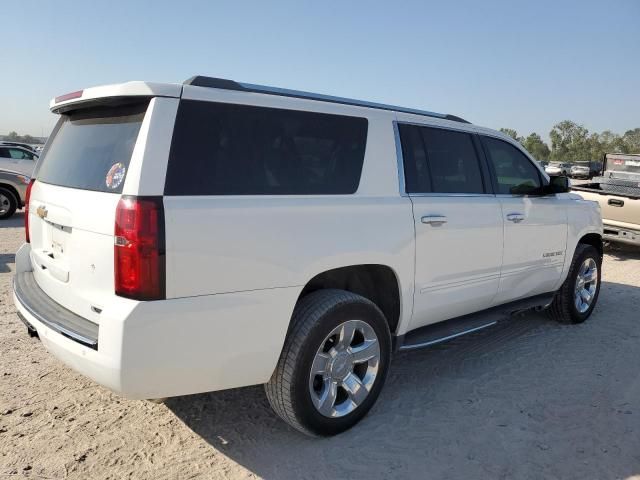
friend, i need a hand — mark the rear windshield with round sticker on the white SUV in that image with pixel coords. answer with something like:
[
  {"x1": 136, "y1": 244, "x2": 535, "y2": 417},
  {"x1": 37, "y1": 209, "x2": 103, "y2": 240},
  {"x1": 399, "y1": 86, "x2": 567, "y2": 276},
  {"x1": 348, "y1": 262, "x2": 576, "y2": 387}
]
[{"x1": 36, "y1": 101, "x2": 149, "y2": 193}]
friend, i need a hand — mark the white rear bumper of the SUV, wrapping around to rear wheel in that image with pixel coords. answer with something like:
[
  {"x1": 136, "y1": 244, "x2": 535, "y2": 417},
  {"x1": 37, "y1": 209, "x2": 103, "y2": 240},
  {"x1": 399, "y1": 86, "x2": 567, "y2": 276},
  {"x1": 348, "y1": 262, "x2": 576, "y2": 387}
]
[{"x1": 13, "y1": 246, "x2": 300, "y2": 399}]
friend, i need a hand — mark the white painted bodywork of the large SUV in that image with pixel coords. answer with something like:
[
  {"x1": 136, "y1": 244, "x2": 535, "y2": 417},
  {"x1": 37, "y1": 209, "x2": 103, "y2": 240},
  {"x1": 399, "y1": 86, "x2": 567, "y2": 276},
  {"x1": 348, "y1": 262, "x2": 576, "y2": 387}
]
[{"x1": 14, "y1": 76, "x2": 602, "y2": 436}]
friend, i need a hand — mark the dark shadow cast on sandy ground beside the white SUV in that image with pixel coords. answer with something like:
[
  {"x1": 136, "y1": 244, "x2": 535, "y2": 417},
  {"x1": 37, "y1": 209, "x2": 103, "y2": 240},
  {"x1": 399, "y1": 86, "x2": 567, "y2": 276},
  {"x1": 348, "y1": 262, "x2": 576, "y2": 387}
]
[{"x1": 166, "y1": 282, "x2": 640, "y2": 479}]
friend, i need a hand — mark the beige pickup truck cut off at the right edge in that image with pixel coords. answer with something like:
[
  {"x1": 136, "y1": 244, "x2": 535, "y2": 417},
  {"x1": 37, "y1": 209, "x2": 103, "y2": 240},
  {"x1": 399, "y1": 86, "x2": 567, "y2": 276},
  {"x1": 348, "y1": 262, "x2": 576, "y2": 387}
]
[{"x1": 571, "y1": 153, "x2": 640, "y2": 246}]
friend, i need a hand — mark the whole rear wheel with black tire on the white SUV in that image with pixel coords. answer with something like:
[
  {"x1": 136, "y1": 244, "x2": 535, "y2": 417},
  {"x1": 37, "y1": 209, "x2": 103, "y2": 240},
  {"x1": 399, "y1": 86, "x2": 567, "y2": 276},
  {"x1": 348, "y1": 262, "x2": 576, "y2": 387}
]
[{"x1": 265, "y1": 289, "x2": 391, "y2": 436}]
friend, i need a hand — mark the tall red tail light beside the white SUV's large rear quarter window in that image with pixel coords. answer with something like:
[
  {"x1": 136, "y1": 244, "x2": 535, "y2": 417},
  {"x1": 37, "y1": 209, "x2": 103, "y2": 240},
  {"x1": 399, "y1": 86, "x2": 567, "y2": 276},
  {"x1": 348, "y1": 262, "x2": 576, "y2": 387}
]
[{"x1": 113, "y1": 196, "x2": 166, "y2": 300}]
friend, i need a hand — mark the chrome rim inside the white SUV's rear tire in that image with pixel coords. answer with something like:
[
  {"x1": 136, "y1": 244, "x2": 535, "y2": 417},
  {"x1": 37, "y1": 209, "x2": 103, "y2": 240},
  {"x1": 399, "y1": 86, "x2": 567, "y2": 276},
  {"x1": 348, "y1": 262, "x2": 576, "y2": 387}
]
[{"x1": 309, "y1": 320, "x2": 380, "y2": 418}]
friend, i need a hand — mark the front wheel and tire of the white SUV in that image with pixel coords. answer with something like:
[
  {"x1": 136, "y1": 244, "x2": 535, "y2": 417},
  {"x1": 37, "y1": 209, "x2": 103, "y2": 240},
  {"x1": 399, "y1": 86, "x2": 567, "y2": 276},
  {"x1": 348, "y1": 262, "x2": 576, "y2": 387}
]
[{"x1": 547, "y1": 243, "x2": 602, "y2": 324}]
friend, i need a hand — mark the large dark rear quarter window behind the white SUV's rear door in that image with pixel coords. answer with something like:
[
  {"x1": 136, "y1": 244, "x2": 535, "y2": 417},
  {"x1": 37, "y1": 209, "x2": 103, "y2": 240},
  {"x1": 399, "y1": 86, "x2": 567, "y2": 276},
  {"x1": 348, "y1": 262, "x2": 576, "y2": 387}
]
[{"x1": 165, "y1": 100, "x2": 367, "y2": 195}]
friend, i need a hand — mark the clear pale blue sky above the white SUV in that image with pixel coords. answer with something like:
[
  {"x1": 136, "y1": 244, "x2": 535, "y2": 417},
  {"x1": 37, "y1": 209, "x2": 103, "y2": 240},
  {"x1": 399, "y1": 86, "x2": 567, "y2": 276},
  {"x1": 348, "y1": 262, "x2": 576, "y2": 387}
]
[{"x1": 0, "y1": 0, "x2": 640, "y2": 139}]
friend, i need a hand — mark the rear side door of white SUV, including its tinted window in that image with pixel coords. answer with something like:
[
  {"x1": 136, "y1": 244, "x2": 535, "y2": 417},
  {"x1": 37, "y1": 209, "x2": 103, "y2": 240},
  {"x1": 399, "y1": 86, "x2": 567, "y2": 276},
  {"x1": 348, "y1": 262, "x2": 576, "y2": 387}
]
[{"x1": 398, "y1": 124, "x2": 503, "y2": 329}]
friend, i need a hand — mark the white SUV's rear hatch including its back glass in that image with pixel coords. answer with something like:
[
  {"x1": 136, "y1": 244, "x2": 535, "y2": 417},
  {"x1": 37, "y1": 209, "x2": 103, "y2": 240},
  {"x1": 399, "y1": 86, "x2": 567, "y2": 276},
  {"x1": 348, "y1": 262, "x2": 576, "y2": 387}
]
[{"x1": 29, "y1": 103, "x2": 149, "y2": 323}]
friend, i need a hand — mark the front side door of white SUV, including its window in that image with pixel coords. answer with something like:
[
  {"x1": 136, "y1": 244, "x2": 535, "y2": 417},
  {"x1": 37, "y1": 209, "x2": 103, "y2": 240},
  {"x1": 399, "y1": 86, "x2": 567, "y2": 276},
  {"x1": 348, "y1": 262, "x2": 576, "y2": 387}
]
[{"x1": 482, "y1": 136, "x2": 570, "y2": 304}]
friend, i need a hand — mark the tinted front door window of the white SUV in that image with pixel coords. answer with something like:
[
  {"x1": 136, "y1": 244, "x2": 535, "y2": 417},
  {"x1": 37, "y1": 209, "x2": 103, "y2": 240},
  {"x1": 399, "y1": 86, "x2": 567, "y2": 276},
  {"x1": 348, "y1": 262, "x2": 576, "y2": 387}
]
[{"x1": 483, "y1": 137, "x2": 542, "y2": 195}]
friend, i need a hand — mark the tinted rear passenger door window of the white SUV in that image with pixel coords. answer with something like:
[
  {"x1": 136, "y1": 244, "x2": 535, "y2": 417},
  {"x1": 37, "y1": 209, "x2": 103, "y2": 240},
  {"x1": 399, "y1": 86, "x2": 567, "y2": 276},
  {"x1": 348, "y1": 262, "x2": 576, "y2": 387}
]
[{"x1": 400, "y1": 125, "x2": 484, "y2": 193}]
